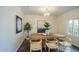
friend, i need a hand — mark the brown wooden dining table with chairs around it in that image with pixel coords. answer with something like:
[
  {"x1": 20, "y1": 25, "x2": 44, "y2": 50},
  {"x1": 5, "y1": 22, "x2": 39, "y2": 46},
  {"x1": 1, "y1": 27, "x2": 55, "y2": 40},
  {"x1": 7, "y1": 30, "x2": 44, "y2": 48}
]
[{"x1": 30, "y1": 33, "x2": 65, "y2": 48}]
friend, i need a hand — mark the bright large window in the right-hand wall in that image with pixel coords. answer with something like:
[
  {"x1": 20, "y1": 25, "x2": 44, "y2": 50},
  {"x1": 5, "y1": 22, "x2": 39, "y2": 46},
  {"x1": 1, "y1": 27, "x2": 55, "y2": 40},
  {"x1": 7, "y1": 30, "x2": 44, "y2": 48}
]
[{"x1": 67, "y1": 19, "x2": 79, "y2": 36}]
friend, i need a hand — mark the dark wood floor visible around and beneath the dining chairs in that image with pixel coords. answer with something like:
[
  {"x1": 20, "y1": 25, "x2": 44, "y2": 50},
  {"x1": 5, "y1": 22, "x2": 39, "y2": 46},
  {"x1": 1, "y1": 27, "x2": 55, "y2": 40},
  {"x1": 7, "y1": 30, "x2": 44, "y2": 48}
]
[{"x1": 17, "y1": 39, "x2": 79, "y2": 52}]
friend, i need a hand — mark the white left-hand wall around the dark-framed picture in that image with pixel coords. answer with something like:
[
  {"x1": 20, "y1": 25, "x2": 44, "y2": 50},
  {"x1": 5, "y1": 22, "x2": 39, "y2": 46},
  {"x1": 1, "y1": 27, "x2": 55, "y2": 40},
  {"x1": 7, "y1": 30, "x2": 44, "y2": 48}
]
[{"x1": 0, "y1": 6, "x2": 24, "y2": 52}]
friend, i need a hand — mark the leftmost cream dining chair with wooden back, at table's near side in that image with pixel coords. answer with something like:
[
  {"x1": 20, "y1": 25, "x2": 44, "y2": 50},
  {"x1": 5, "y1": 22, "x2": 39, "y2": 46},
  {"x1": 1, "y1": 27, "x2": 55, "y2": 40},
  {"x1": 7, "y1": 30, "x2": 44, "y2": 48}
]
[{"x1": 30, "y1": 36, "x2": 42, "y2": 52}]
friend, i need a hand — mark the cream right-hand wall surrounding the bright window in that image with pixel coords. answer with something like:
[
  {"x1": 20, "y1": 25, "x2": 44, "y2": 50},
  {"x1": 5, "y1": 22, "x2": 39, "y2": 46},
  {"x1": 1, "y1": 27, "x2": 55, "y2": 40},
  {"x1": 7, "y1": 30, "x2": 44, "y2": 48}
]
[{"x1": 57, "y1": 8, "x2": 79, "y2": 47}]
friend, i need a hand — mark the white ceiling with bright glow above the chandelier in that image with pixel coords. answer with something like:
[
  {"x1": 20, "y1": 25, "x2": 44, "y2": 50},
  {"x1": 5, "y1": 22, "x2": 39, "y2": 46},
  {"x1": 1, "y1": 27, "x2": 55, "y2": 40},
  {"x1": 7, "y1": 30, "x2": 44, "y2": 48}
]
[{"x1": 20, "y1": 6, "x2": 79, "y2": 16}]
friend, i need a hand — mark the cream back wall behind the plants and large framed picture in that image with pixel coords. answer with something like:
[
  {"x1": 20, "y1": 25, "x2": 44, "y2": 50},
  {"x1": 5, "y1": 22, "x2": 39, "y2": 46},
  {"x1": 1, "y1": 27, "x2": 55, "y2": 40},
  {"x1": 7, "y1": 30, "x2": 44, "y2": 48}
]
[{"x1": 24, "y1": 15, "x2": 56, "y2": 37}]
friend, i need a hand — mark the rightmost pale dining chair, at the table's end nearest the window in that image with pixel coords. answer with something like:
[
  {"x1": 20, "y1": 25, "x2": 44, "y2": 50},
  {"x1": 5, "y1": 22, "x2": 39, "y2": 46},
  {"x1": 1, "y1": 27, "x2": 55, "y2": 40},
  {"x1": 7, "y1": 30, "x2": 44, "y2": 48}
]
[{"x1": 59, "y1": 37, "x2": 72, "y2": 51}]
